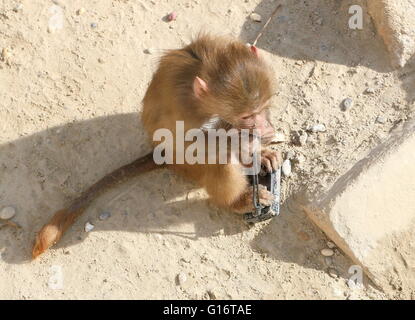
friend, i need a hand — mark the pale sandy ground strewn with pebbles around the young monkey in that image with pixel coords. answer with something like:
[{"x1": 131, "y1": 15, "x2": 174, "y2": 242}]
[{"x1": 0, "y1": 0, "x2": 415, "y2": 299}]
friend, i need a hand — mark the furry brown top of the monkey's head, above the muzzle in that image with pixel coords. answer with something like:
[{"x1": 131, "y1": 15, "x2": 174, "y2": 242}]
[{"x1": 185, "y1": 34, "x2": 273, "y2": 118}]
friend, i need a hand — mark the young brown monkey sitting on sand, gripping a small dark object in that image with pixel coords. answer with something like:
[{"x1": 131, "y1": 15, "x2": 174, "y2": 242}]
[{"x1": 32, "y1": 35, "x2": 281, "y2": 258}]
